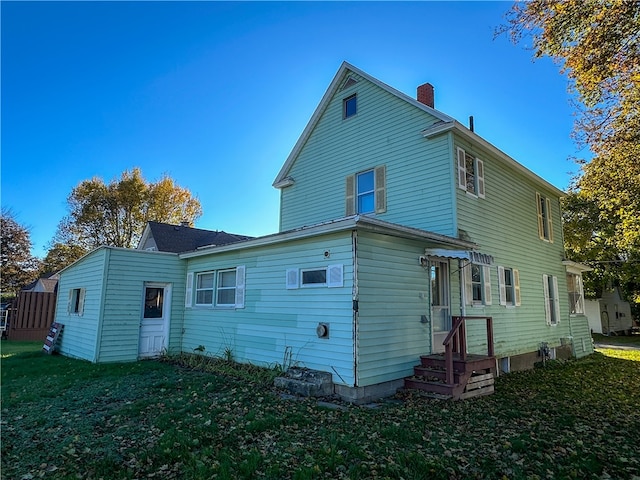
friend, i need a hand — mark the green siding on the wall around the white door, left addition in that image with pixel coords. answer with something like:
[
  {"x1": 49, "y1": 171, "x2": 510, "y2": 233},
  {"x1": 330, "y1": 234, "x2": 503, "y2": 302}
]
[{"x1": 98, "y1": 249, "x2": 185, "y2": 362}]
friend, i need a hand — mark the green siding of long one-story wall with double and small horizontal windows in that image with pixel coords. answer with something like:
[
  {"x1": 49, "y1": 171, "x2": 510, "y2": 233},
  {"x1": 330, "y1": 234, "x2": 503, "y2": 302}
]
[{"x1": 183, "y1": 231, "x2": 354, "y2": 385}]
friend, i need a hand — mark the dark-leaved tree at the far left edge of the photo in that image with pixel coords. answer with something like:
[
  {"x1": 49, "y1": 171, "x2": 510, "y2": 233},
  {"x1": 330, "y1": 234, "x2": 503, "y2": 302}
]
[{"x1": 0, "y1": 208, "x2": 39, "y2": 296}]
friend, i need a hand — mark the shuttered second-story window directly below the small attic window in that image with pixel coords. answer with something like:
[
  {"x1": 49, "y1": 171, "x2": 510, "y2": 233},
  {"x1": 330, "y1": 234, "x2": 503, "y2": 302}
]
[{"x1": 345, "y1": 165, "x2": 387, "y2": 216}]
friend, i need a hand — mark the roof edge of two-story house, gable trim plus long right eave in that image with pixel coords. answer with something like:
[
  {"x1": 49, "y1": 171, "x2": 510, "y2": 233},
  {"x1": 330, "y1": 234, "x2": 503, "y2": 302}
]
[{"x1": 273, "y1": 62, "x2": 565, "y2": 196}]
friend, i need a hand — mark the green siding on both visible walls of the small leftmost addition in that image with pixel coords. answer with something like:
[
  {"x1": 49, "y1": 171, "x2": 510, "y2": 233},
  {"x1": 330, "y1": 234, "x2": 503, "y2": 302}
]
[{"x1": 56, "y1": 247, "x2": 185, "y2": 362}]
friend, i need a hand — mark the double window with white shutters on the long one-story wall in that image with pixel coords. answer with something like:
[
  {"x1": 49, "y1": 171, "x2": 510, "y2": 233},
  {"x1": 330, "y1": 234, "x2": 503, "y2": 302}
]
[{"x1": 185, "y1": 265, "x2": 245, "y2": 308}]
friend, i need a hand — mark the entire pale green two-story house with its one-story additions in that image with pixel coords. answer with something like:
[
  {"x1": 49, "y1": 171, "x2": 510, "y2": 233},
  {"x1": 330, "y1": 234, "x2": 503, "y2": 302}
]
[{"x1": 56, "y1": 63, "x2": 593, "y2": 402}]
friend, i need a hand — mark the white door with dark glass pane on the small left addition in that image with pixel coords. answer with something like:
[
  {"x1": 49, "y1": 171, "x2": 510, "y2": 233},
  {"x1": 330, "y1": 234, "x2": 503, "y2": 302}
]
[{"x1": 138, "y1": 283, "x2": 171, "y2": 358}]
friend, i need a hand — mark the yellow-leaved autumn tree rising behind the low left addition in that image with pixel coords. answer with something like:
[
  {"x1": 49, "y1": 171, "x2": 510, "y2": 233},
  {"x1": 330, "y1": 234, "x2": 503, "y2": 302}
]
[{"x1": 52, "y1": 168, "x2": 202, "y2": 253}]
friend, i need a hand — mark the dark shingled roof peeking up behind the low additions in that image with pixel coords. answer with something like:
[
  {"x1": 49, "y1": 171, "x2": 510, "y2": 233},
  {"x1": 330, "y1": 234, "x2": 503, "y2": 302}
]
[{"x1": 138, "y1": 222, "x2": 253, "y2": 253}]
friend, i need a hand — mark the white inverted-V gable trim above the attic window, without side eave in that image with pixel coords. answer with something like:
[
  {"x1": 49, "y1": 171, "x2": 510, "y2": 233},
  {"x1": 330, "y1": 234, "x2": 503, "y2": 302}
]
[{"x1": 273, "y1": 62, "x2": 454, "y2": 188}]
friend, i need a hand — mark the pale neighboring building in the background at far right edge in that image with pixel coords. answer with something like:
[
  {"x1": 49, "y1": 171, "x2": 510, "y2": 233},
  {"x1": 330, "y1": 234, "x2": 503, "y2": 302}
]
[{"x1": 585, "y1": 287, "x2": 633, "y2": 335}]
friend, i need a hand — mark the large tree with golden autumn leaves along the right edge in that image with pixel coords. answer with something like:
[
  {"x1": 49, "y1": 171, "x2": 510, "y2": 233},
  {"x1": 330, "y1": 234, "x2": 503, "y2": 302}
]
[{"x1": 498, "y1": 0, "x2": 640, "y2": 305}]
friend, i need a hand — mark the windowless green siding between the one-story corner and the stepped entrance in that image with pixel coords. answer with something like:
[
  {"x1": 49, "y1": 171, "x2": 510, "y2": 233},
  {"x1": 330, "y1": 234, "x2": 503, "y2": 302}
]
[{"x1": 357, "y1": 232, "x2": 431, "y2": 386}]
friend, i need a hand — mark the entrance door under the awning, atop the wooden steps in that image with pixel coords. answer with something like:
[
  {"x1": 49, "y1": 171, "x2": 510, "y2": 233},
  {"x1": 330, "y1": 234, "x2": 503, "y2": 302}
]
[{"x1": 430, "y1": 260, "x2": 451, "y2": 353}]
